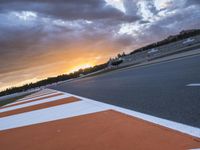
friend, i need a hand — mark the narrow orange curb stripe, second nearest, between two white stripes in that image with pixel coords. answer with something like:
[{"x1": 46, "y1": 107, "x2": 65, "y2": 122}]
[{"x1": 0, "y1": 97, "x2": 79, "y2": 118}]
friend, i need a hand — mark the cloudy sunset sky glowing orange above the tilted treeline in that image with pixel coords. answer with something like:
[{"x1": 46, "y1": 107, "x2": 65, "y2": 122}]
[{"x1": 0, "y1": 0, "x2": 200, "y2": 90}]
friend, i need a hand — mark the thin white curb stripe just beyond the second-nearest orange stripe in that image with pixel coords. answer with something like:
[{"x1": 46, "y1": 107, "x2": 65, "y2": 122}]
[{"x1": 0, "y1": 94, "x2": 70, "y2": 113}]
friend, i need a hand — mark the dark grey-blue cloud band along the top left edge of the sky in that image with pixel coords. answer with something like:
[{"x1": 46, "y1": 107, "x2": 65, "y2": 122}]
[{"x1": 0, "y1": 0, "x2": 138, "y2": 21}]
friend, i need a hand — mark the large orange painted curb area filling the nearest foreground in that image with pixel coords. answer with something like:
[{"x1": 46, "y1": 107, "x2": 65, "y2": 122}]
[{"x1": 0, "y1": 110, "x2": 200, "y2": 150}]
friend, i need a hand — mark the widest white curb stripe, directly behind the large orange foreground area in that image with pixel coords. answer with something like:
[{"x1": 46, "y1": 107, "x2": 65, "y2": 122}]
[{"x1": 0, "y1": 101, "x2": 106, "y2": 131}]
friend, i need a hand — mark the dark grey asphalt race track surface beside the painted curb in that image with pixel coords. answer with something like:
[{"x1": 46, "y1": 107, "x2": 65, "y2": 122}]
[{"x1": 51, "y1": 55, "x2": 200, "y2": 128}]
